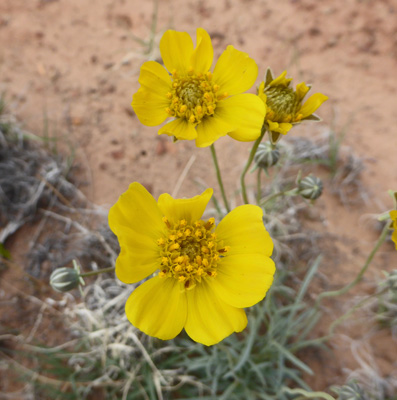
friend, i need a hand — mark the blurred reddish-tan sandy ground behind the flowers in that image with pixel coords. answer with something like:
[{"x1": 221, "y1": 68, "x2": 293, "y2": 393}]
[{"x1": 0, "y1": 0, "x2": 397, "y2": 389}]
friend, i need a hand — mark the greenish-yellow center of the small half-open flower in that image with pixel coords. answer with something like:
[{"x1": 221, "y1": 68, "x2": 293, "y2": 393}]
[{"x1": 264, "y1": 86, "x2": 301, "y2": 122}]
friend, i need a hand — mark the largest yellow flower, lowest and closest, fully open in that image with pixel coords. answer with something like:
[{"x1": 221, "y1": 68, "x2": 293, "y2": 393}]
[{"x1": 109, "y1": 182, "x2": 275, "y2": 346}]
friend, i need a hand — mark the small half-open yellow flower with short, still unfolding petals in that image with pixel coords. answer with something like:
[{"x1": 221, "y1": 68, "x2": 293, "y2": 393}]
[{"x1": 258, "y1": 68, "x2": 328, "y2": 144}]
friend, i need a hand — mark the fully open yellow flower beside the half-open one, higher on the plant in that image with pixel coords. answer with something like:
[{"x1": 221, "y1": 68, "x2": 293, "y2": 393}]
[{"x1": 131, "y1": 28, "x2": 265, "y2": 147}]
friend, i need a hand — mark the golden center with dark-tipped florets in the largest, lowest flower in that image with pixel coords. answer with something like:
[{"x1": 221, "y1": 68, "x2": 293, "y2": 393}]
[{"x1": 157, "y1": 217, "x2": 229, "y2": 289}]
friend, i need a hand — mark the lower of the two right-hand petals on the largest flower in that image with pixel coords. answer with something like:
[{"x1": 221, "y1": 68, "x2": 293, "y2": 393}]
[{"x1": 211, "y1": 254, "x2": 276, "y2": 308}]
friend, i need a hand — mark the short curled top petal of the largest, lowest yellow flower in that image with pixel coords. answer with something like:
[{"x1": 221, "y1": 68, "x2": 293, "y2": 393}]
[{"x1": 158, "y1": 189, "x2": 213, "y2": 222}]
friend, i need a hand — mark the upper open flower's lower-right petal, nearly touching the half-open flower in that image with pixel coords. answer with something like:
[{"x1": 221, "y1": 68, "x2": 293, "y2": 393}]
[{"x1": 215, "y1": 93, "x2": 266, "y2": 142}]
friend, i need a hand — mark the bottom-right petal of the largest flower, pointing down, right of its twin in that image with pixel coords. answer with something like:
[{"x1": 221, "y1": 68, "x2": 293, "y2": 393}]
[{"x1": 185, "y1": 281, "x2": 247, "y2": 346}]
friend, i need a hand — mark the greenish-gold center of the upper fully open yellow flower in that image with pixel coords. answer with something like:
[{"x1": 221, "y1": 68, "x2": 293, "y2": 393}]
[{"x1": 166, "y1": 70, "x2": 228, "y2": 126}]
